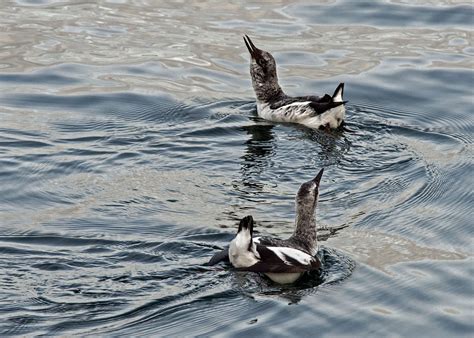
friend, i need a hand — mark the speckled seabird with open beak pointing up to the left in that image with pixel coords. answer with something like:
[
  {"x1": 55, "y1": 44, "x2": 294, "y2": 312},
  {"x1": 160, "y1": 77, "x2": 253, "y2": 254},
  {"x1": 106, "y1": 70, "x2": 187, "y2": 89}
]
[{"x1": 244, "y1": 35, "x2": 347, "y2": 130}]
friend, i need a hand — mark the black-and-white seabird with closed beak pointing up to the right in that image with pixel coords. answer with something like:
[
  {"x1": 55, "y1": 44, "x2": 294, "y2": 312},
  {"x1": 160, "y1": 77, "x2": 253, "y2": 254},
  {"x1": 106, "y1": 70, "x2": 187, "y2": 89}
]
[{"x1": 208, "y1": 169, "x2": 324, "y2": 284}]
